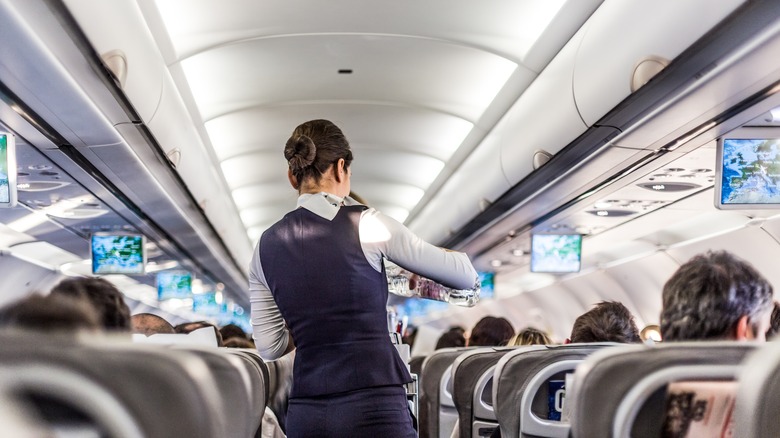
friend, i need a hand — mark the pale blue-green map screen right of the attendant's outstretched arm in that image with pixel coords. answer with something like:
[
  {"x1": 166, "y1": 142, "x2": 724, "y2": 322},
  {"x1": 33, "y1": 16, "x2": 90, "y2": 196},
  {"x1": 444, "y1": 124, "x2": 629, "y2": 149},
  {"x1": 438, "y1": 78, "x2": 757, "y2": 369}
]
[{"x1": 531, "y1": 234, "x2": 582, "y2": 274}]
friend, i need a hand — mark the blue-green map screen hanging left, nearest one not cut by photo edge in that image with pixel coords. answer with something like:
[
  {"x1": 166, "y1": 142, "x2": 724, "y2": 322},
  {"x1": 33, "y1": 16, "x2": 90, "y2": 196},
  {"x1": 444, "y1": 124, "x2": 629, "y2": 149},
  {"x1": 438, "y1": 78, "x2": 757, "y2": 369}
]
[{"x1": 92, "y1": 233, "x2": 146, "y2": 275}]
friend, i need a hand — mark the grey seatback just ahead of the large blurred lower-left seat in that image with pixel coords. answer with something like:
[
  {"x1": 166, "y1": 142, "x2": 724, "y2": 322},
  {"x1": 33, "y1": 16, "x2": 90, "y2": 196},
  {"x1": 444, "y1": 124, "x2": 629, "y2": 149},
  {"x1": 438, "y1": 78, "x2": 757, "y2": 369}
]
[{"x1": 174, "y1": 346, "x2": 253, "y2": 437}]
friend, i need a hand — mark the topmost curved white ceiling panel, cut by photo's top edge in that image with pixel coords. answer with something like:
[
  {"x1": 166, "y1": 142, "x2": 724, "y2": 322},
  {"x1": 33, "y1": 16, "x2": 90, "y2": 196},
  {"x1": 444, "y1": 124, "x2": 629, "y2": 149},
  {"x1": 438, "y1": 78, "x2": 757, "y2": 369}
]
[{"x1": 146, "y1": 0, "x2": 601, "y2": 71}]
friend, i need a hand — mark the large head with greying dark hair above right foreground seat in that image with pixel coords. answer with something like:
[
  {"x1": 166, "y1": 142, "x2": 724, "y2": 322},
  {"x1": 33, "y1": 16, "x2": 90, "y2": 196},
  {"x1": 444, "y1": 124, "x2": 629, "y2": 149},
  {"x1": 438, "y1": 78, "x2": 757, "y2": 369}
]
[{"x1": 661, "y1": 251, "x2": 772, "y2": 341}]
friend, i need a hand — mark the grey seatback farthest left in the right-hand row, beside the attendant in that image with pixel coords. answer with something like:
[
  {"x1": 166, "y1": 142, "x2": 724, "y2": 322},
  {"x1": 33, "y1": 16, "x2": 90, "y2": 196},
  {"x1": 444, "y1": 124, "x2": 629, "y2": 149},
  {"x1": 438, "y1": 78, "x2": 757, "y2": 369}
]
[{"x1": 418, "y1": 347, "x2": 470, "y2": 438}]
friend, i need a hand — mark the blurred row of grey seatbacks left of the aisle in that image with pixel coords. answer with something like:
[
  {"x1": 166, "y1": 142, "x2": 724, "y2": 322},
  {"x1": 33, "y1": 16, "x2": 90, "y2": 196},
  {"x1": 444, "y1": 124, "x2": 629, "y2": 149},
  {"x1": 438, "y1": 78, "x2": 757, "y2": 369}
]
[{"x1": 0, "y1": 331, "x2": 291, "y2": 438}]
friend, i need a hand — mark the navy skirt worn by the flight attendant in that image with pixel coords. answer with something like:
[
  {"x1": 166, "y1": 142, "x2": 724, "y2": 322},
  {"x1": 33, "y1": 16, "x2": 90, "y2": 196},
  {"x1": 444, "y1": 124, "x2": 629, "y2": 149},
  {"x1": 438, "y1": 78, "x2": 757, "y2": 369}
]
[{"x1": 286, "y1": 386, "x2": 417, "y2": 438}]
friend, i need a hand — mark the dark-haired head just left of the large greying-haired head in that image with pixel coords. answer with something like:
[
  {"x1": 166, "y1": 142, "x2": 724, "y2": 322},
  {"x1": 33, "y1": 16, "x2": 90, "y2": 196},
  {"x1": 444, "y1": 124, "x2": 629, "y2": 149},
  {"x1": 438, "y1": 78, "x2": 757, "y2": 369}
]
[{"x1": 567, "y1": 301, "x2": 641, "y2": 344}]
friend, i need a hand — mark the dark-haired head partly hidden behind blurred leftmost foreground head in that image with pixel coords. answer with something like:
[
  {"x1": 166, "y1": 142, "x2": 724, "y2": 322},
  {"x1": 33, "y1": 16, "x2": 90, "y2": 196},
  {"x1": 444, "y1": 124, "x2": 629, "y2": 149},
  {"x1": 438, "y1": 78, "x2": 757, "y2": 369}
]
[{"x1": 51, "y1": 277, "x2": 131, "y2": 331}]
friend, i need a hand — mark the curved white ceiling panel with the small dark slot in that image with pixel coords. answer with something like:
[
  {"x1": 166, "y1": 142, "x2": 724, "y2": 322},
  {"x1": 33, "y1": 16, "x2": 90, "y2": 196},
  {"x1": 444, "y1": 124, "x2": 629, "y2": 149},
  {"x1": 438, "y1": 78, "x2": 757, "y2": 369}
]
[{"x1": 181, "y1": 35, "x2": 516, "y2": 121}]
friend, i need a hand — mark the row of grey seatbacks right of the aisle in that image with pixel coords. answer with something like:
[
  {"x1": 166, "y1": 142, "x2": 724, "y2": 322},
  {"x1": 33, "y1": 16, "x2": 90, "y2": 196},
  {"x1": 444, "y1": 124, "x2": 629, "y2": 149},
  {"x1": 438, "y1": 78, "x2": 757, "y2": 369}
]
[{"x1": 420, "y1": 341, "x2": 780, "y2": 438}]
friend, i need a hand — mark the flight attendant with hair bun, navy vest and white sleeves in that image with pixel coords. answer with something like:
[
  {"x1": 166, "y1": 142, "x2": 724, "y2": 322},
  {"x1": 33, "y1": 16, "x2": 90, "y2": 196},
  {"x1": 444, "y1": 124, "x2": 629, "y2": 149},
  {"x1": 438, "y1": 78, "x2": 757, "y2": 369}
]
[{"x1": 249, "y1": 120, "x2": 477, "y2": 437}]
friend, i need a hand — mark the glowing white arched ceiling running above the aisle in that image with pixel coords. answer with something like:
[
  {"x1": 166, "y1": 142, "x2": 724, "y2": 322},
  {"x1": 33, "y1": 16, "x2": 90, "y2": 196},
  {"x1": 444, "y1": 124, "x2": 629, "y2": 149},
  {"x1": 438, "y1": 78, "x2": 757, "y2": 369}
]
[{"x1": 138, "y1": 0, "x2": 600, "y2": 246}]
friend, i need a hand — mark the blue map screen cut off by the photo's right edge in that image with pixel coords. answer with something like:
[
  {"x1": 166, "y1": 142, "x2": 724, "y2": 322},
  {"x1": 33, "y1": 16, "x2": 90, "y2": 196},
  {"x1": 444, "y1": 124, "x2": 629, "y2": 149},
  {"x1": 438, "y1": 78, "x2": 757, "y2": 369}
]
[{"x1": 720, "y1": 138, "x2": 780, "y2": 205}]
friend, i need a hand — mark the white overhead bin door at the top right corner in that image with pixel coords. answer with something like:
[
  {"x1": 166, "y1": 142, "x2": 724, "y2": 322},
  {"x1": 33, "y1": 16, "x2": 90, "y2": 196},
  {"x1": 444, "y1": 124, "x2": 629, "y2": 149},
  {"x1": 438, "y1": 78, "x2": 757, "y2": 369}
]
[{"x1": 572, "y1": 0, "x2": 743, "y2": 128}]
